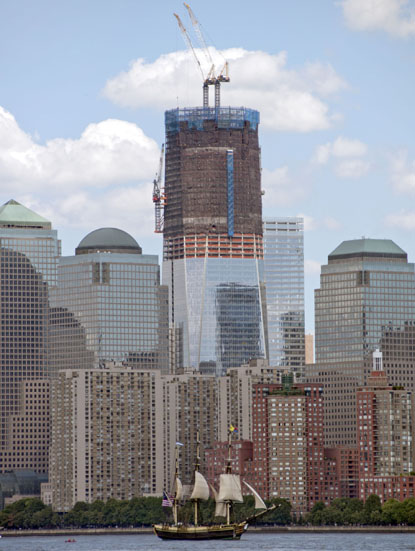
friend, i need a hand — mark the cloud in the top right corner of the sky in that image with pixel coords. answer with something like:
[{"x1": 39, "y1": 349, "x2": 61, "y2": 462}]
[{"x1": 340, "y1": 0, "x2": 415, "y2": 37}]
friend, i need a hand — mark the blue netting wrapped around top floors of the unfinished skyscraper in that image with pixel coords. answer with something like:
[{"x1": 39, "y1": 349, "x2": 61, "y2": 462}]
[{"x1": 165, "y1": 107, "x2": 259, "y2": 133}]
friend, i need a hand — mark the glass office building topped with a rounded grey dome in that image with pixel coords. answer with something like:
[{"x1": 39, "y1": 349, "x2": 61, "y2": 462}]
[{"x1": 53, "y1": 228, "x2": 169, "y2": 373}]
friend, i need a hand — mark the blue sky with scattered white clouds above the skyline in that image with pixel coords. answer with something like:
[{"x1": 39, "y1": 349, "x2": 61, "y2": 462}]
[{"x1": 0, "y1": 0, "x2": 415, "y2": 332}]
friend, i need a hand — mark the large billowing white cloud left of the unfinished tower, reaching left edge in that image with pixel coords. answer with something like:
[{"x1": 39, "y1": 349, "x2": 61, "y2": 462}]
[{"x1": 0, "y1": 107, "x2": 158, "y2": 193}]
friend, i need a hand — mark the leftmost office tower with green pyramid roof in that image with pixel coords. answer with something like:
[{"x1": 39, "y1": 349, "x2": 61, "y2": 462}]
[{"x1": 0, "y1": 200, "x2": 60, "y2": 473}]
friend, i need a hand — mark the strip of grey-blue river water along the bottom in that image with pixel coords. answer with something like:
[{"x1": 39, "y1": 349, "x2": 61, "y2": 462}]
[{"x1": 0, "y1": 532, "x2": 415, "y2": 551}]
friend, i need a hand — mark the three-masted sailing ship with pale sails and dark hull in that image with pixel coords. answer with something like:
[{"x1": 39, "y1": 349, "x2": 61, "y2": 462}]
[{"x1": 153, "y1": 430, "x2": 277, "y2": 540}]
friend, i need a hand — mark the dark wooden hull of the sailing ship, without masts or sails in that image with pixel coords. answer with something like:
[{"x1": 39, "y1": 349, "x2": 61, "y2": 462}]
[{"x1": 153, "y1": 522, "x2": 248, "y2": 540}]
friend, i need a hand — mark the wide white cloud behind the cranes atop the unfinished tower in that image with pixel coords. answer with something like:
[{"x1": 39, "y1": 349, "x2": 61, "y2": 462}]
[{"x1": 103, "y1": 48, "x2": 345, "y2": 132}]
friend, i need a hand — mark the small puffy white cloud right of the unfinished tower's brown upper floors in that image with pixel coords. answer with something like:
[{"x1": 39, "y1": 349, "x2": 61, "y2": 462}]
[{"x1": 313, "y1": 136, "x2": 370, "y2": 179}]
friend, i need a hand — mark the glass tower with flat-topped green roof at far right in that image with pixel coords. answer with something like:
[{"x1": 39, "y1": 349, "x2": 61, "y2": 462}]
[{"x1": 315, "y1": 239, "x2": 415, "y2": 363}]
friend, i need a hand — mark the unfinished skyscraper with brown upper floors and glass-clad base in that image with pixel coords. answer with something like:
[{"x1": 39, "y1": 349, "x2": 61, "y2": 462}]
[{"x1": 163, "y1": 107, "x2": 266, "y2": 375}]
